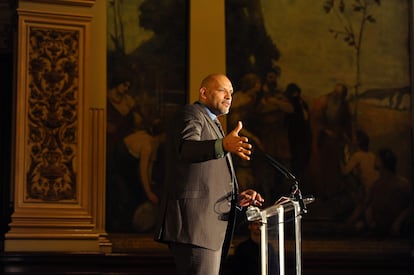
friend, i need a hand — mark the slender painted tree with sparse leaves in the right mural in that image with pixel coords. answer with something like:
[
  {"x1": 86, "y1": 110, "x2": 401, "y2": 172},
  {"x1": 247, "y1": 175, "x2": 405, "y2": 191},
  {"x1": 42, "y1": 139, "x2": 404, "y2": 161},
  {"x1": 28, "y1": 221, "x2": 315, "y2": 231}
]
[{"x1": 323, "y1": 0, "x2": 381, "y2": 120}]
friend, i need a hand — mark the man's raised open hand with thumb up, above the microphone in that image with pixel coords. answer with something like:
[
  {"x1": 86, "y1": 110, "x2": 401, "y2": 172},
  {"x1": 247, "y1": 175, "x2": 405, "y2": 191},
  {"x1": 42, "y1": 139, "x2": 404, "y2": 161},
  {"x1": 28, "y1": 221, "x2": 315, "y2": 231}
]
[{"x1": 223, "y1": 121, "x2": 252, "y2": 160}]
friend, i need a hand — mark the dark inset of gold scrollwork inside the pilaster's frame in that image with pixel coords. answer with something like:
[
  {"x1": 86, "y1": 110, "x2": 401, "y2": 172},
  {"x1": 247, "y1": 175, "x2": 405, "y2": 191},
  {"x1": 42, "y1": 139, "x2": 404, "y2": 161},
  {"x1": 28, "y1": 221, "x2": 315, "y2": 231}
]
[{"x1": 26, "y1": 27, "x2": 80, "y2": 201}]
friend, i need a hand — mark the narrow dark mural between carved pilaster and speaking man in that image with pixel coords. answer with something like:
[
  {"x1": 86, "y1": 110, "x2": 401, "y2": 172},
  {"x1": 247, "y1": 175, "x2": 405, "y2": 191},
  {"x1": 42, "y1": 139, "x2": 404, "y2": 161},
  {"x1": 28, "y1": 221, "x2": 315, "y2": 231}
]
[{"x1": 106, "y1": 0, "x2": 188, "y2": 233}]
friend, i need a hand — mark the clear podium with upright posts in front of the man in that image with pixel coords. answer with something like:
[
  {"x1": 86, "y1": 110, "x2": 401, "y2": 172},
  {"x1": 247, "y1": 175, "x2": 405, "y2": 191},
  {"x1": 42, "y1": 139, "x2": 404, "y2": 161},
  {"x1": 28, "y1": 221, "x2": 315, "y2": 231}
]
[{"x1": 246, "y1": 197, "x2": 315, "y2": 275}]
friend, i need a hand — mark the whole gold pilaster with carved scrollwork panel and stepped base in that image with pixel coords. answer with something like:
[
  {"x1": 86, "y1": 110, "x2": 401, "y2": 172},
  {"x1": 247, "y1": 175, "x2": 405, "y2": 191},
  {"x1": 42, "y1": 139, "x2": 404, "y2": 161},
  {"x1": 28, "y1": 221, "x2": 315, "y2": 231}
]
[{"x1": 6, "y1": 10, "x2": 103, "y2": 251}]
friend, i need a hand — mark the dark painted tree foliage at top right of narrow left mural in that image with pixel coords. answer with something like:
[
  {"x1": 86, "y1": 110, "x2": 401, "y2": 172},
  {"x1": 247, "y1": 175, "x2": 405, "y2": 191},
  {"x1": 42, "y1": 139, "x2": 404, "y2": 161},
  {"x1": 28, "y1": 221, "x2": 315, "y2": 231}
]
[{"x1": 133, "y1": 0, "x2": 189, "y2": 90}]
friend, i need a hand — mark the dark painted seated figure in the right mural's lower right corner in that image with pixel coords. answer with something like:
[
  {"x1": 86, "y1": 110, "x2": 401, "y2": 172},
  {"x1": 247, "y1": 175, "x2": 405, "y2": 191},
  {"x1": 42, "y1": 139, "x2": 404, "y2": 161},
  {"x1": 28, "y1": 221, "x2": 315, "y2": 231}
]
[{"x1": 359, "y1": 148, "x2": 413, "y2": 236}]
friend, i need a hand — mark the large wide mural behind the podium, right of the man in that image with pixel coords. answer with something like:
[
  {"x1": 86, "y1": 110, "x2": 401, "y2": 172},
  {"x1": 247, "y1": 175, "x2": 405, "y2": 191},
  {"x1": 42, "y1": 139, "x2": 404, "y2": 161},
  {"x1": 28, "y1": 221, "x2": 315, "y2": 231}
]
[{"x1": 226, "y1": 0, "x2": 413, "y2": 239}]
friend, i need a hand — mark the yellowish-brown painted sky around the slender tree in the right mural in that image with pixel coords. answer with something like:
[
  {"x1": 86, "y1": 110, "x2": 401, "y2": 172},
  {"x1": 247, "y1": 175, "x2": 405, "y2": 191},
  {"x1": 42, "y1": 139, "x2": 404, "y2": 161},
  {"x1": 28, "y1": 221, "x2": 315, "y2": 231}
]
[{"x1": 261, "y1": 0, "x2": 410, "y2": 96}]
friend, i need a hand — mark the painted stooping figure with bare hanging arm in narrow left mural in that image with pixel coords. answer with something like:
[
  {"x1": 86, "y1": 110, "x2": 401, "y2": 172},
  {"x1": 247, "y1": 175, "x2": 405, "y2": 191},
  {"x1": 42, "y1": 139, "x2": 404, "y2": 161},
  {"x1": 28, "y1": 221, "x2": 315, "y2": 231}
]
[{"x1": 107, "y1": 120, "x2": 165, "y2": 232}]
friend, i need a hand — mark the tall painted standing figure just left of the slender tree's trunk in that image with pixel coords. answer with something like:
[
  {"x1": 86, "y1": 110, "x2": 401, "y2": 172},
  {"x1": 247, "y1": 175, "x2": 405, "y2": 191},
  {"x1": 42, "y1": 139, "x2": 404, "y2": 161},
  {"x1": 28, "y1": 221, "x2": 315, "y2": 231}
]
[{"x1": 307, "y1": 84, "x2": 352, "y2": 208}]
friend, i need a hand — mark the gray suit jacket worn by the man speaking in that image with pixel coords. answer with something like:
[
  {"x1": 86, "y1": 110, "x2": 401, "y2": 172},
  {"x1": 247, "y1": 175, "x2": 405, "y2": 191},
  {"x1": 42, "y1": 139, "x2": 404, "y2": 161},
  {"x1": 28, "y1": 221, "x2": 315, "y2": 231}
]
[{"x1": 155, "y1": 103, "x2": 237, "y2": 253}]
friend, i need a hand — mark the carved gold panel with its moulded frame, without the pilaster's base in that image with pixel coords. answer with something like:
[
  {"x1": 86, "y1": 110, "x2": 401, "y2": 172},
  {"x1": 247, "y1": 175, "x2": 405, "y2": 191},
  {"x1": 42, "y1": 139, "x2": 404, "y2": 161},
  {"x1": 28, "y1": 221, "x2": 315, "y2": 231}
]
[{"x1": 18, "y1": 8, "x2": 89, "y2": 207}]
